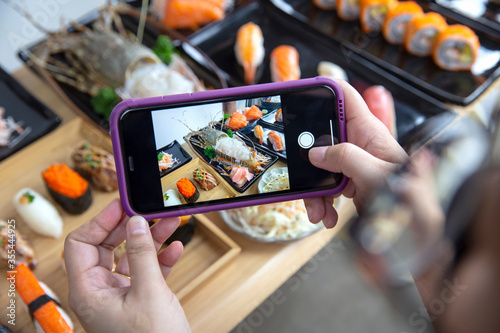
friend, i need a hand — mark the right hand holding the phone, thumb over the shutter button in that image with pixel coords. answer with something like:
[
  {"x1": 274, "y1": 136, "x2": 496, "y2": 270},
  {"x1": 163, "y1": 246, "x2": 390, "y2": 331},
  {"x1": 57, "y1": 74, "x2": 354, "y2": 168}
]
[{"x1": 304, "y1": 80, "x2": 408, "y2": 228}]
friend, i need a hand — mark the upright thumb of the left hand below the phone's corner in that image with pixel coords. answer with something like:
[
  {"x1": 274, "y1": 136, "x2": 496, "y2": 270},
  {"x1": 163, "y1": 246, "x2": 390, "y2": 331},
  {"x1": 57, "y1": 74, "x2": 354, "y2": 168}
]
[{"x1": 127, "y1": 216, "x2": 164, "y2": 293}]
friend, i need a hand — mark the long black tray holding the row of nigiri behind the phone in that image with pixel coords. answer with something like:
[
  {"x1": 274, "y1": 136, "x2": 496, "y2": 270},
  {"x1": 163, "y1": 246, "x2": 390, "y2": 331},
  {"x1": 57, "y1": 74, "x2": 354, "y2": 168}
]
[{"x1": 186, "y1": 2, "x2": 458, "y2": 146}]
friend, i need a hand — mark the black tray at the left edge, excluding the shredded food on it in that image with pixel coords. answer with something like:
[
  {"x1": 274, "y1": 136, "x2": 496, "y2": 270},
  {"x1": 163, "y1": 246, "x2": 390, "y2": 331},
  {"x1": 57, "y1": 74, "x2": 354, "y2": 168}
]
[{"x1": 0, "y1": 67, "x2": 61, "y2": 161}]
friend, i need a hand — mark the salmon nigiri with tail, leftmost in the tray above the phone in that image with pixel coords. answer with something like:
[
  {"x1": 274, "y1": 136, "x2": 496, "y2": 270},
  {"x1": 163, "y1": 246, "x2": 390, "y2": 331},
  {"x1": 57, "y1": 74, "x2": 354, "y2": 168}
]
[{"x1": 234, "y1": 22, "x2": 265, "y2": 84}]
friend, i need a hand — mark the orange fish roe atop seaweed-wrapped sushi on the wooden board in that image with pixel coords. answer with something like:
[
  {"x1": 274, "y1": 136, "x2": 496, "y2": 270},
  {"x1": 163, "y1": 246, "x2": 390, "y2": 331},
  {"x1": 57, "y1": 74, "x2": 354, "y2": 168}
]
[{"x1": 42, "y1": 163, "x2": 89, "y2": 198}]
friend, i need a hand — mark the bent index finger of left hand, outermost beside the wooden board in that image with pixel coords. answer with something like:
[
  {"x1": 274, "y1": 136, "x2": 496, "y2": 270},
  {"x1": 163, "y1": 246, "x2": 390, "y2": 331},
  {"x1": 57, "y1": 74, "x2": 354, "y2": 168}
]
[{"x1": 64, "y1": 199, "x2": 123, "y2": 281}]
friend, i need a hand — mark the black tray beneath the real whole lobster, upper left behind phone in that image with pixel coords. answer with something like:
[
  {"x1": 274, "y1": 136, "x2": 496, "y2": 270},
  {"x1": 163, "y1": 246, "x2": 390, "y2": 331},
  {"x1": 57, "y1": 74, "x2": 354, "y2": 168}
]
[{"x1": 18, "y1": 0, "x2": 223, "y2": 130}]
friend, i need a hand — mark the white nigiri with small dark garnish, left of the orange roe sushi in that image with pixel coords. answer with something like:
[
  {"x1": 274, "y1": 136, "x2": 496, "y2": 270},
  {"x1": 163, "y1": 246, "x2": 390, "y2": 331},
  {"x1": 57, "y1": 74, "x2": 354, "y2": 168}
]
[{"x1": 12, "y1": 188, "x2": 63, "y2": 238}]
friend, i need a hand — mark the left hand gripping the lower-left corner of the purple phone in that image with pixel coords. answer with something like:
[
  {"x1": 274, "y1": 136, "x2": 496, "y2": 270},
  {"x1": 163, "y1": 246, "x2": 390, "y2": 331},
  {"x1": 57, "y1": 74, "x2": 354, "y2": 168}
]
[{"x1": 64, "y1": 200, "x2": 190, "y2": 332}]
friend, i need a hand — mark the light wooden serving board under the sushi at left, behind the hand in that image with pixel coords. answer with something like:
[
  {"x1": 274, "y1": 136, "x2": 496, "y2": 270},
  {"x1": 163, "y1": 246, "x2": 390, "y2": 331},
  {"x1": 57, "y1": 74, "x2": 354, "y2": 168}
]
[{"x1": 0, "y1": 119, "x2": 240, "y2": 332}]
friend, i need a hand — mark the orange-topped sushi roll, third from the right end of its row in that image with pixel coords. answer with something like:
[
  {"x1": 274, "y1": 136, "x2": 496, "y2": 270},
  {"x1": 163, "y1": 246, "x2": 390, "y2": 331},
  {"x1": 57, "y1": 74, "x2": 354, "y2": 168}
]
[{"x1": 382, "y1": 1, "x2": 424, "y2": 45}]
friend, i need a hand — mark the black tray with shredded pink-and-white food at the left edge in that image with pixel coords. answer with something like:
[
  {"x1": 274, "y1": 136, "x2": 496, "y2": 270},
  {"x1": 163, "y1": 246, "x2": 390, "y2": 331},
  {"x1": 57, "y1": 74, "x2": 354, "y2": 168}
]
[{"x1": 0, "y1": 67, "x2": 61, "y2": 161}]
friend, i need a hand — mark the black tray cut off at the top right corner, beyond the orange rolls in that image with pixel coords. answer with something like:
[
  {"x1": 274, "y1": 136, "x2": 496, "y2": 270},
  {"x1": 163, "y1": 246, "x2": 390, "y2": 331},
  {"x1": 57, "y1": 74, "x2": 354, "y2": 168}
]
[{"x1": 422, "y1": 0, "x2": 500, "y2": 38}]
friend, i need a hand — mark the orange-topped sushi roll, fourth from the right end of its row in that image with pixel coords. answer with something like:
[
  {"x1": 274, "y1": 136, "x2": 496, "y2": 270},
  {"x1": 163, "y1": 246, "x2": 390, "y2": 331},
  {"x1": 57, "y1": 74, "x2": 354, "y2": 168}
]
[{"x1": 359, "y1": 0, "x2": 397, "y2": 34}]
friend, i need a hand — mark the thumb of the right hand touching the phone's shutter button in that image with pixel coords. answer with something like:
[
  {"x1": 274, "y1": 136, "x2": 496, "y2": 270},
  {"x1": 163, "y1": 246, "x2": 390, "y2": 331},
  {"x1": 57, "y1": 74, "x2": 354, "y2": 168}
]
[{"x1": 309, "y1": 143, "x2": 392, "y2": 186}]
